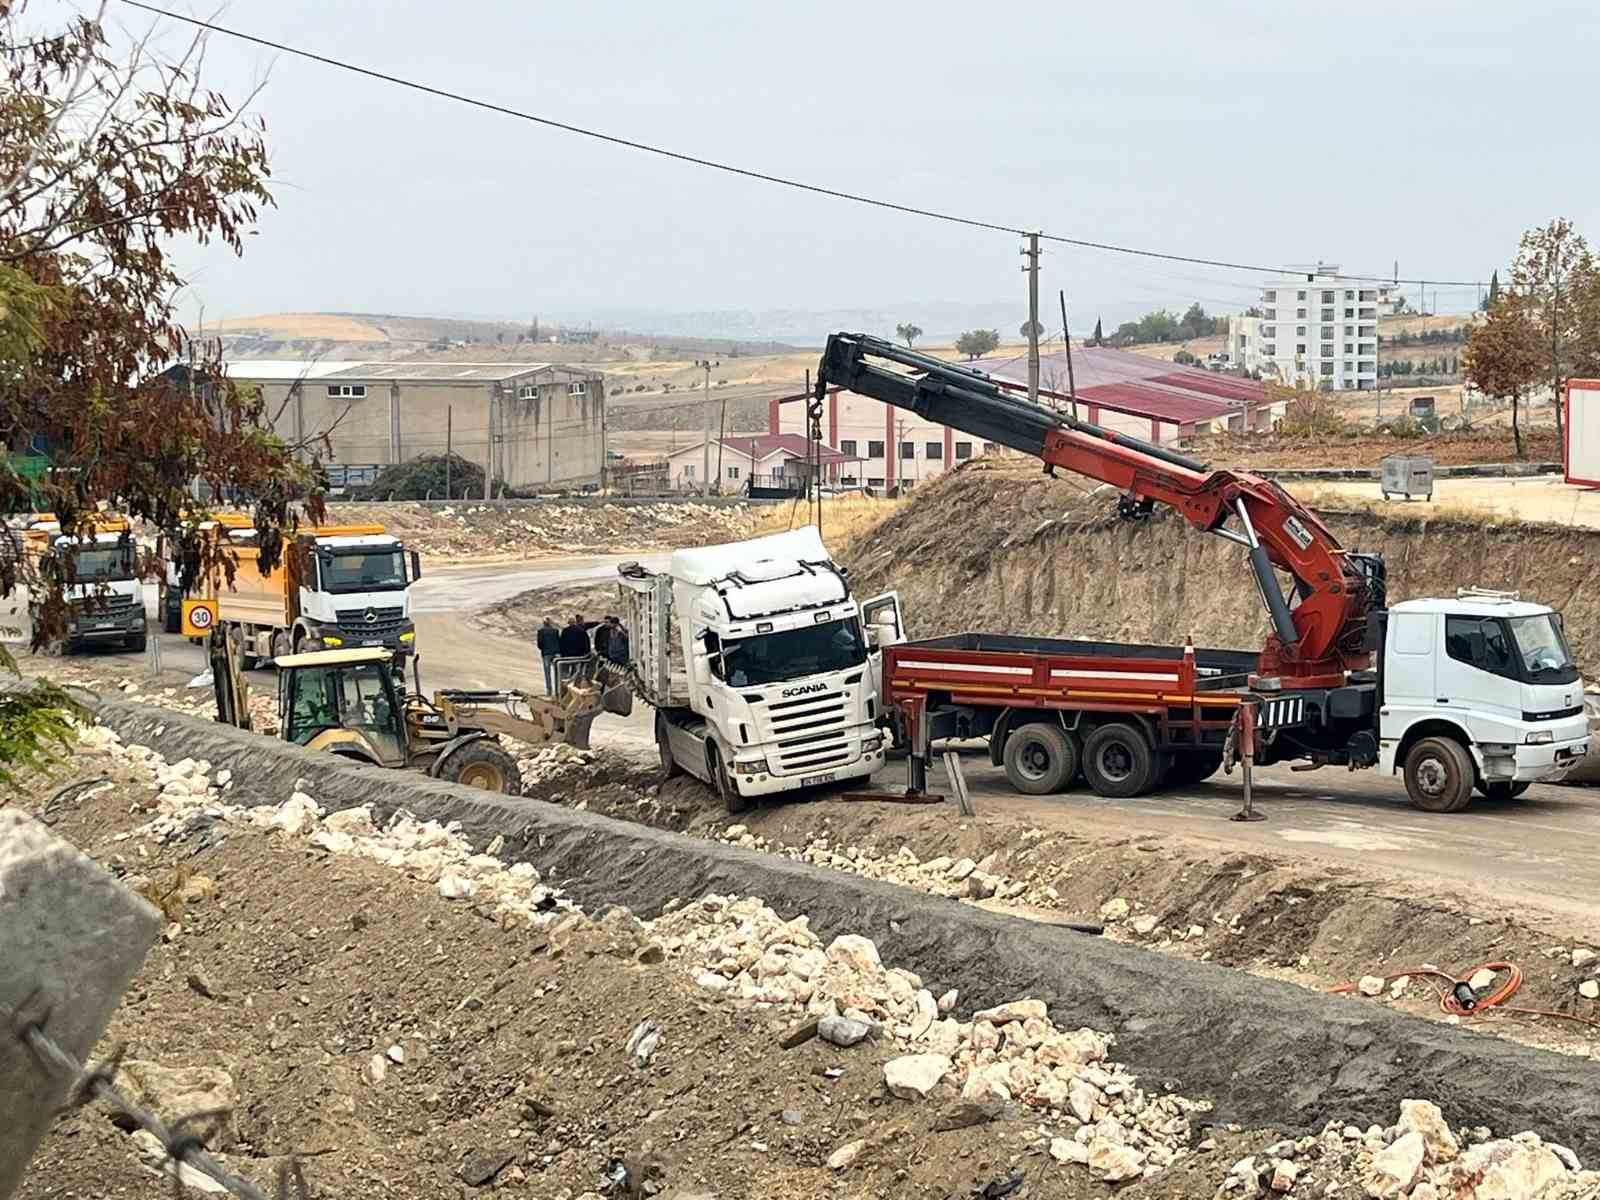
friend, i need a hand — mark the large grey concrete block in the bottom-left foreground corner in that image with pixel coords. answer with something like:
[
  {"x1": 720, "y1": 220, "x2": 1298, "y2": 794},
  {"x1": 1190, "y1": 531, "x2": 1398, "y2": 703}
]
[{"x1": 0, "y1": 808, "x2": 160, "y2": 1200}]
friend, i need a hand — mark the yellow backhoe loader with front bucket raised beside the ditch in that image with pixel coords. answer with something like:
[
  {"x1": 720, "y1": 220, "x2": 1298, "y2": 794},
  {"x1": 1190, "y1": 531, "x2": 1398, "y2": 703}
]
[{"x1": 210, "y1": 629, "x2": 632, "y2": 795}]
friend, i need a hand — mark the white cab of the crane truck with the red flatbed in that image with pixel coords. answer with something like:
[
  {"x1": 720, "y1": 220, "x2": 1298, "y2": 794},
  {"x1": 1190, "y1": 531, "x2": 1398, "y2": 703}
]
[{"x1": 1378, "y1": 589, "x2": 1589, "y2": 811}]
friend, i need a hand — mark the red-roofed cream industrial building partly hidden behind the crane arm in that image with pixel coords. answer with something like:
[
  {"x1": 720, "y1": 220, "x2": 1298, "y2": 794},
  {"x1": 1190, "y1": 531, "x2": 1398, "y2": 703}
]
[{"x1": 768, "y1": 346, "x2": 1282, "y2": 488}]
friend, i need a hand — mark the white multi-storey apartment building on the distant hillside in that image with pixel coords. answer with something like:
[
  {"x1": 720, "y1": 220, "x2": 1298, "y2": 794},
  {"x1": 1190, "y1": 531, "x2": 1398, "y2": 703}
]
[{"x1": 1248, "y1": 262, "x2": 1382, "y2": 392}]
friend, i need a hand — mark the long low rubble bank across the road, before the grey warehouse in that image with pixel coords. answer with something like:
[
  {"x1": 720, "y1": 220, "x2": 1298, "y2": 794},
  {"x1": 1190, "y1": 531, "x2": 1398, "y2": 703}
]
[{"x1": 338, "y1": 501, "x2": 755, "y2": 560}]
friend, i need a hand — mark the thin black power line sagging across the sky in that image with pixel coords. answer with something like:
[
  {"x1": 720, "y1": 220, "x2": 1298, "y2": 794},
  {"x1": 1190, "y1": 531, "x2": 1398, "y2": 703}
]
[{"x1": 122, "y1": 0, "x2": 1483, "y2": 288}]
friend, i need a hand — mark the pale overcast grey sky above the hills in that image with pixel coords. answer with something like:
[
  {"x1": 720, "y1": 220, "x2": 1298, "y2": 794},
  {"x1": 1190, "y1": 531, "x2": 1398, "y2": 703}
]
[{"x1": 62, "y1": 0, "x2": 1600, "y2": 336}]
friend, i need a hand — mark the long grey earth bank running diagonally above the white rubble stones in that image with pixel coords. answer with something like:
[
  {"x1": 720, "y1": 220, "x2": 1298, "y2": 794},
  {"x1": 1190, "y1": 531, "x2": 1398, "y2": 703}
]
[{"x1": 101, "y1": 701, "x2": 1600, "y2": 1157}]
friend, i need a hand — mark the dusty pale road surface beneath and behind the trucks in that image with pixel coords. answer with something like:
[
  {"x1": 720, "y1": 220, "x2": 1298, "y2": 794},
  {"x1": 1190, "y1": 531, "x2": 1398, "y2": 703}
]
[{"x1": 93, "y1": 554, "x2": 1600, "y2": 925}]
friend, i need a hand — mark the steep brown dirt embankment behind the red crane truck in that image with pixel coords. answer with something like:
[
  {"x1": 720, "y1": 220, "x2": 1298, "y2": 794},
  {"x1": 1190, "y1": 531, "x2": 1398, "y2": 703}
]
[{"x1": 843, "y1": 462, "x2": 1600, "y2": 677}]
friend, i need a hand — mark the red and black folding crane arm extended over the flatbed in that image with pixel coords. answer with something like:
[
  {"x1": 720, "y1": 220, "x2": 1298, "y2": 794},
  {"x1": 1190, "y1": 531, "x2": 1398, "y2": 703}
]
[{"x1": 816, "y1": 333, "x2": 1384, "y2": 686}]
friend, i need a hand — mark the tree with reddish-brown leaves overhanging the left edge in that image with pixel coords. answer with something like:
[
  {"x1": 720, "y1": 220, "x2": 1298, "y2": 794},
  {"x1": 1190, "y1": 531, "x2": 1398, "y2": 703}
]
[{"x1": 0, "y1": 0, "x2": 320, "y2": 763}]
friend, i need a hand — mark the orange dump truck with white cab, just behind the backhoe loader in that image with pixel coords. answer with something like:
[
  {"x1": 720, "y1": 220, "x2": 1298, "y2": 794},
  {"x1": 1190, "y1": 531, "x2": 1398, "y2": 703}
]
[{"x1": 195, "y1": 514, "x2": 422, "y2": 670}]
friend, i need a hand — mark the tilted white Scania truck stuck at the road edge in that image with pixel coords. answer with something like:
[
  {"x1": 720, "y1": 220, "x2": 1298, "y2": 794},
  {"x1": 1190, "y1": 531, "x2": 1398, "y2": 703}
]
[{"x1": 619, "y1": 526, "x2": 904, "y2": 813}]
